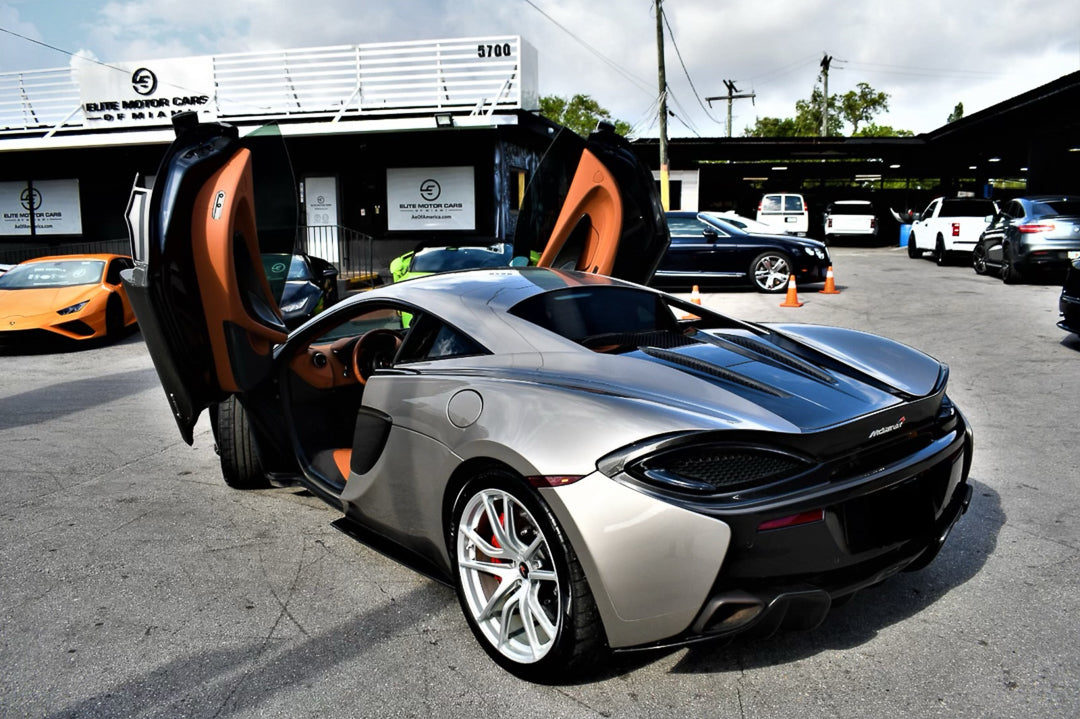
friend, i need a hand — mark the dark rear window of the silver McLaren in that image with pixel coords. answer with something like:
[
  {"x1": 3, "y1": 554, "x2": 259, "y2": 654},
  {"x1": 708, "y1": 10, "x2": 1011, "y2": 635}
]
[{"x1": 510, "y1": 287, "x2": 678, "y2": 342}]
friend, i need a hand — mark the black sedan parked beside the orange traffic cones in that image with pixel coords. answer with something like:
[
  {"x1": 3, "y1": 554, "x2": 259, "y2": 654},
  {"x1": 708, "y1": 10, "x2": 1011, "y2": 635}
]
[{"x1": 652, "y1": 212, "x2": 831, "y2": 293}]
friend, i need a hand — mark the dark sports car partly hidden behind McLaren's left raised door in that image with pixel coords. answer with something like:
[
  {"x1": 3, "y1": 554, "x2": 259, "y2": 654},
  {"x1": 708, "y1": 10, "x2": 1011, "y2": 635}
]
[{"x1": 262, "y1": 253, "x2": 338, "y2": 328}]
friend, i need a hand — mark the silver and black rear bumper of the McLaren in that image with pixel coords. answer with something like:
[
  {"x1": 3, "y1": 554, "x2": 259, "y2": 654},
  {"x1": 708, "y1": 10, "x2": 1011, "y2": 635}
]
[{"x1": 543, "y1": 403, "x2": 972, "y2": 650}]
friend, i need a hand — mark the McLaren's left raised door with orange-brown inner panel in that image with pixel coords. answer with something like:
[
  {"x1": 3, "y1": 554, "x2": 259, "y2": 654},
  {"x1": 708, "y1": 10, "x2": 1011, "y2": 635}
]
[{"x1": 124, "y1": 118, "x2": 295, "y2": 444}]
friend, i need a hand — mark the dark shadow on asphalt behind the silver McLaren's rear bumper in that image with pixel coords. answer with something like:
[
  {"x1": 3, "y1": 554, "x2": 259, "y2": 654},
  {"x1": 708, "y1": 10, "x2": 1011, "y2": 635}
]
[{"x1": 672, "y1": 480, "x2": 1005, "y2": 674}]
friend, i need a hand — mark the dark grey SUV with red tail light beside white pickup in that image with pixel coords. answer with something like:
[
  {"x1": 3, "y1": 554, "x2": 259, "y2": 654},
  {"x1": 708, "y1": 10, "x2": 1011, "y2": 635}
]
[{"x1": 971, "y1": 194, "x2": 1080, "y2": 283}]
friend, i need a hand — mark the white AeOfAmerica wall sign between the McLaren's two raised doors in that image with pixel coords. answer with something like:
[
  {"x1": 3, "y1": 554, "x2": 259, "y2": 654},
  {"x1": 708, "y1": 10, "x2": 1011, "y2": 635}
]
[{"x1": 387, "y1": 166, "x2": 476, "y2": 230}]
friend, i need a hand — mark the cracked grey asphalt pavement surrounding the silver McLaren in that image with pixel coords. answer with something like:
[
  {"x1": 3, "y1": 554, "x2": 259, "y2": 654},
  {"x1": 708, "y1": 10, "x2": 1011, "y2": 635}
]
[{"x1": 0, "y1": 247, "x2": 1080, "y2": 719}]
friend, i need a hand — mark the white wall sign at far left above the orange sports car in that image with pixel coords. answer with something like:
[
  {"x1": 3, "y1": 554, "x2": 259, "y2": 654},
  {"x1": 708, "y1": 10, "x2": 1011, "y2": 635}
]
[{"x1": 0, "y1": 179, "x2": 82, "y2": 235}]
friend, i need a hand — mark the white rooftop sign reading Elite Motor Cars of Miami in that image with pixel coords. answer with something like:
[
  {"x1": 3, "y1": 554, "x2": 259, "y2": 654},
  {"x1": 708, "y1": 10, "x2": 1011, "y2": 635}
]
[{"x1": 77, "y1": 56, "x2": 214, "y2": 128}]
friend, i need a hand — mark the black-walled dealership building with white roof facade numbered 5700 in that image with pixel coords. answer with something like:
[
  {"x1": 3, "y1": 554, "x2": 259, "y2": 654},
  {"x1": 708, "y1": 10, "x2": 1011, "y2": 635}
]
[{"x1": 0, "y1": 37, "x2": 555, "y2": 274}]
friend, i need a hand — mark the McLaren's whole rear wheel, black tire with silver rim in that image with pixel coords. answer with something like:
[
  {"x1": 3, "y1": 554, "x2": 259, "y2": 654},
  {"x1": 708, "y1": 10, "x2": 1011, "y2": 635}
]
[{"x1": 447, "y1": 470, "x2": 608, "y2": 682}]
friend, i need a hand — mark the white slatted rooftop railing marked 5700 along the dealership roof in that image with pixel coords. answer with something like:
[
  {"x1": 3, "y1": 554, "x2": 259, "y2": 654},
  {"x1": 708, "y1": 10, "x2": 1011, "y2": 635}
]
[{"x1": 0, "y1": 36, "x2": 539, "y2": 136}]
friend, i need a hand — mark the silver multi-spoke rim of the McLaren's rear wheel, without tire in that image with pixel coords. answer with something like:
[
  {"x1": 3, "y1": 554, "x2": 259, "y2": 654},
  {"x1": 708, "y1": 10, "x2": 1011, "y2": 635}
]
[{"x1": 457, "y1": 489, "x2": 562, "y2": 664}]
